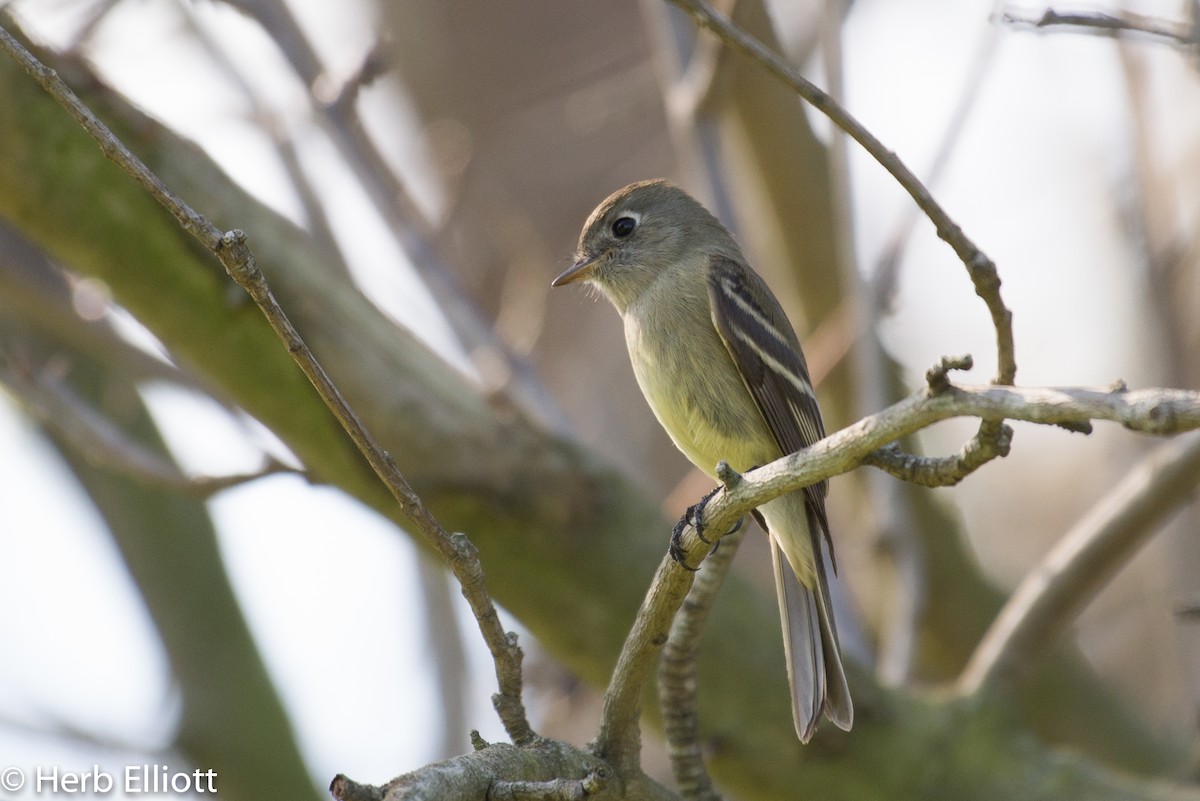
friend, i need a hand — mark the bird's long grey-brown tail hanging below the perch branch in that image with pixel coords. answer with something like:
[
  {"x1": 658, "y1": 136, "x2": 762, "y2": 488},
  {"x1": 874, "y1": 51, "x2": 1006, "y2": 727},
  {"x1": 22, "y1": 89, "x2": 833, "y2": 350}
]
[{"x1": 762, "y1": 495, "x2": 854, "y2": 742}]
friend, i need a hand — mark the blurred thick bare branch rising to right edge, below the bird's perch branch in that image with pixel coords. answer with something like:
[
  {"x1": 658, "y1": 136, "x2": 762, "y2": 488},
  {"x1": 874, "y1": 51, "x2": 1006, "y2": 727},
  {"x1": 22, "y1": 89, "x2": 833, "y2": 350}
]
[{"x1": 959, "y1": 434, "x2": 1200, "y2": 694}]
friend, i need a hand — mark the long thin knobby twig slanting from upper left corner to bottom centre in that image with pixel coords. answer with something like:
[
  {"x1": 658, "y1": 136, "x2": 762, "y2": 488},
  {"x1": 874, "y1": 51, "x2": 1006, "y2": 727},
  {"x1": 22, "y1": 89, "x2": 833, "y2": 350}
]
[{"x1": 0, "y1": 28, "x2": 536, "y2": 746}]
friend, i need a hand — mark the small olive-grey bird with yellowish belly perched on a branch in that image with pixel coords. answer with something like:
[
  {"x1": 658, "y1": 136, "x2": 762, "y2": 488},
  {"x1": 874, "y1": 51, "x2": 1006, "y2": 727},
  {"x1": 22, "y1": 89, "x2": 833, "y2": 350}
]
[{"x1": 551, "y1": 180, "x2": 854, "y2": 743}]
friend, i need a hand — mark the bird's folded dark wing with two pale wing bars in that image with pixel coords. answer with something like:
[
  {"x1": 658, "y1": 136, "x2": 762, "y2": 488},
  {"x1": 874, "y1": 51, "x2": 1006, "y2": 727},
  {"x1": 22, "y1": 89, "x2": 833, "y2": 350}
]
[{"x1": 708, "y1": 255, "x2": 836, "y2": 551}]
